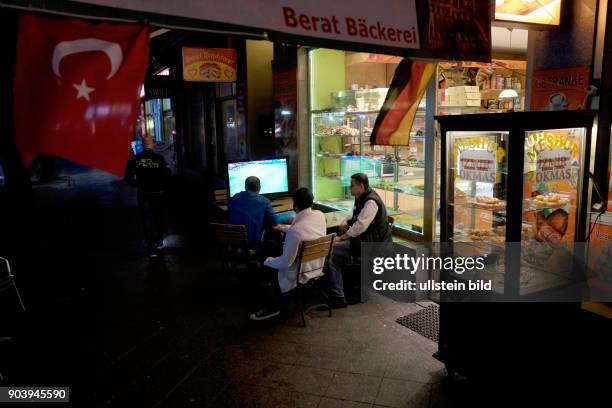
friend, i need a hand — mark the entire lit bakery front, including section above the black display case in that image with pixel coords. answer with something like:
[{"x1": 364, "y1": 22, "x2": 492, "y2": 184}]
[{"x1": 298, "y1": 33, "x2": 527, "y2": 241}]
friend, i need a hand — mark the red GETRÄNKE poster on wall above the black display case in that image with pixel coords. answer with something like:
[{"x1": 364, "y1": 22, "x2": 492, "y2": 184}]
[{"x1": 531, "y1": 67, "x2": 589, "y2": 111}]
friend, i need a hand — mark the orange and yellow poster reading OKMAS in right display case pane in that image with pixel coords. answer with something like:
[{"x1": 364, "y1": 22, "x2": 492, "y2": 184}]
[{"x1": 523, "y1": 129, "x2": 584, "y2": 243}]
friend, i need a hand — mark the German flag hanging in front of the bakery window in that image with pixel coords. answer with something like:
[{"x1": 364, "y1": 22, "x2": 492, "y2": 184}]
[{"x1": 370, "y1": 59, "x2": 436, "y2": 146}]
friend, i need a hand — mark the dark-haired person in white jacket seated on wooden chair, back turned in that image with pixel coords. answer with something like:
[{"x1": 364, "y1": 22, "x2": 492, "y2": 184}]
[{"x1": 251, "y1": 188, "x2": 327, "y2": 320}]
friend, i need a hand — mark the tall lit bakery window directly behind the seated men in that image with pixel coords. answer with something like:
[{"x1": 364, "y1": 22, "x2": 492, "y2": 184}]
[{"x1": 310, "y1": 49, "x2": 426, "y2": 233}]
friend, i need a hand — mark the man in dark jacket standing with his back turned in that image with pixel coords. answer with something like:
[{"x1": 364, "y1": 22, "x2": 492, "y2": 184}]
[{"x1": 124, "y1": 137, "x2": 170, "y2": 258}]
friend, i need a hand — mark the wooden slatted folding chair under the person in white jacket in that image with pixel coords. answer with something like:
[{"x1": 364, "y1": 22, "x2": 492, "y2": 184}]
[{"x1": 287, "y1": 234, "x2": 336, "y2": 327}]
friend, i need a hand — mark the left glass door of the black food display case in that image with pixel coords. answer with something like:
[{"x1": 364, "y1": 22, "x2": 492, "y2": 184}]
[{"x1": 447, "y1": 131, "x2": 509, "y2": 294}]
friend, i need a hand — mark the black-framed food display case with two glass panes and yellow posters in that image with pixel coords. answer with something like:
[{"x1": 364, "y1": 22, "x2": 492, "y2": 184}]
[{"x1": 436, "y1": 111, "x2": 594, "y2": 300}]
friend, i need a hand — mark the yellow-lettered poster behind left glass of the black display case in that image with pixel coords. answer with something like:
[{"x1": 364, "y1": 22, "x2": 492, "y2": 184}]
[{"x1": 452, "y1": 134, "x2": 506, "y2": 235}]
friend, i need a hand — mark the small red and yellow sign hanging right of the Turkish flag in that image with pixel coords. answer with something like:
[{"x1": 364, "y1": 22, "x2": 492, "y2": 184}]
[{"x1": 183, "y1": 47, "x2": 237, "y2": 82}]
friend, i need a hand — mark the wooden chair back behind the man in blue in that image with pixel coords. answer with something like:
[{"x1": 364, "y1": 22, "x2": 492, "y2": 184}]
[{"x1": 210, "y1": 223, "x2": 257, "y2": 271}]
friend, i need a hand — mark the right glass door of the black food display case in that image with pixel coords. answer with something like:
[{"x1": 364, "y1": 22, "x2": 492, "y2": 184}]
[{"x1": 520, "y1": 128, "x2": 587, "y2": 295}]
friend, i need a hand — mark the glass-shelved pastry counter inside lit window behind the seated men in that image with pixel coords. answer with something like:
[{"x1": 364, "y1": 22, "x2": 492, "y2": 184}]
[{"x1": 311, "y1": 103, "x2": 425, "y2": 233}]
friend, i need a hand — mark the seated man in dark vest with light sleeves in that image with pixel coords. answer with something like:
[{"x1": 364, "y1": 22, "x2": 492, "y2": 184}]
[{"x1": 330, "y1": 173, "x2": 391, "y2": 307}]
